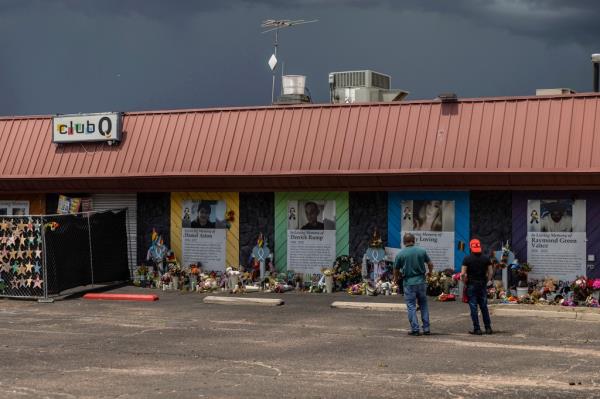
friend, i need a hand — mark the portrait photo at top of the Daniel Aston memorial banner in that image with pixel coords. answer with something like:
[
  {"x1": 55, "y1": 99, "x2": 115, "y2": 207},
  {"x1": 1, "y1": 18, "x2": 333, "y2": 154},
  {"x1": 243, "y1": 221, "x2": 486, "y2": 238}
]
[{"x1": 181, "y1": 200, "x2": 227, "y2": 229}]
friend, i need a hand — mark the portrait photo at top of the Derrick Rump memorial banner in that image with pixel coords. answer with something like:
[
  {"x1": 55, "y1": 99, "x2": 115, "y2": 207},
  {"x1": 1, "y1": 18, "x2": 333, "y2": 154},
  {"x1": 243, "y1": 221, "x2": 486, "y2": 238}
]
[{"x1": 287, "y1": 200, "x2": 335, "y2": 230}]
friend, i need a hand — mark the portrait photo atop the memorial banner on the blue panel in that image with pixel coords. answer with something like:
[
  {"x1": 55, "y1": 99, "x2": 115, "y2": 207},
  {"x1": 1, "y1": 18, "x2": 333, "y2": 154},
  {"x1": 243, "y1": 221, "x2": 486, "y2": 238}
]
[{"x1": 401, "y1": 200, "x2": 454, "y2": 231}]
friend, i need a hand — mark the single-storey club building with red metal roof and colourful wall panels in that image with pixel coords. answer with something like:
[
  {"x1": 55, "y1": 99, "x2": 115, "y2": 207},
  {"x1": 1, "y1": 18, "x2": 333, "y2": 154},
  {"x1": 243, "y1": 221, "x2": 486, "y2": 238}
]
[{"x1": 0, "y1": 93, "x2": 600, "y2": 294}]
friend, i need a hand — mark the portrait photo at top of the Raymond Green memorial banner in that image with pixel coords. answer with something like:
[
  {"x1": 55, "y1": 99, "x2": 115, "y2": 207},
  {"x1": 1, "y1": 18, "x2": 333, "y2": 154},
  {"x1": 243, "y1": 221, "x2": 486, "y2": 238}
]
[{"x1": 527, "y1": 199, "x2": 586, "y2": 233}]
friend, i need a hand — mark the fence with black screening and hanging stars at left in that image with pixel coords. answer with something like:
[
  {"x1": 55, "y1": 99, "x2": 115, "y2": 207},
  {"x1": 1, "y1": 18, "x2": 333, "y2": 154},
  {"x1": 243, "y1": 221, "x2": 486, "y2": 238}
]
[{"x1": 0, "y1": 209, "x2": 130, "y2": 299}]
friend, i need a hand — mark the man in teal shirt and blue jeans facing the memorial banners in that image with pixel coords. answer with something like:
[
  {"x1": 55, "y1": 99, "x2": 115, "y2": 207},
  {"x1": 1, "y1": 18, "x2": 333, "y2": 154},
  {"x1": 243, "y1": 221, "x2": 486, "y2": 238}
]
[{"x1": 394, "y1": 233, "x2": 433, "y2": 336}]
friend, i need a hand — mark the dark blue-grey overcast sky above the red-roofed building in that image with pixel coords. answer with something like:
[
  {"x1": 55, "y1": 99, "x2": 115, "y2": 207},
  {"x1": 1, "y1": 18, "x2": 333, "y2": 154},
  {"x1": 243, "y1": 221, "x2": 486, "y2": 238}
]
[{"x1": 0, "y1": 0, "x2": 600, "y2": 115}]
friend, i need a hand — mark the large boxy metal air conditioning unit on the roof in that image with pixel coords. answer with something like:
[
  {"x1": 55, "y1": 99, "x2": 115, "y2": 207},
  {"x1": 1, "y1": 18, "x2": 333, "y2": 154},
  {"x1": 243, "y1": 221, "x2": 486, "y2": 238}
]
[{"x1": 329, "y1": 69, "x2": 408, "y2": 104}]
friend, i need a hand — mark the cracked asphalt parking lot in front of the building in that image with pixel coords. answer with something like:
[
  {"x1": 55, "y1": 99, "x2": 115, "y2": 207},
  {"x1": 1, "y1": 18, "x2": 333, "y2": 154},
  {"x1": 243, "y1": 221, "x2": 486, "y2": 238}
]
[{"x1": 0, "y1": 287, "x2": 600, "y2": 398}]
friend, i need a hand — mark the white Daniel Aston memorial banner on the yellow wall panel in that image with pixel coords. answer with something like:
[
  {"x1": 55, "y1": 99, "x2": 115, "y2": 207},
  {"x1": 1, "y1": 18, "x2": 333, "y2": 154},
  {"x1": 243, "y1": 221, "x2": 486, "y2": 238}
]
[{"x1": 181, "y1": 200, "x2": 227, "y2": 271}]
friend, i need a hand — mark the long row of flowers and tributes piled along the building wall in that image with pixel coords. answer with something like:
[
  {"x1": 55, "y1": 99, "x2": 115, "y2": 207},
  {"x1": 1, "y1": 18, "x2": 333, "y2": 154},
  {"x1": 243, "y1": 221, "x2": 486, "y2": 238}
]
[{"x1": 131, "y1": 230, "x2": 600, "y2": 307}]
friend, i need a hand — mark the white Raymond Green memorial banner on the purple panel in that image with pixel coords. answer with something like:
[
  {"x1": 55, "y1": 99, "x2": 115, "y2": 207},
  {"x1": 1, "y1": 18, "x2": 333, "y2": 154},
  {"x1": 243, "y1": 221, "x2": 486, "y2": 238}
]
[{"x1": 526, "y1": 199, "x2": 587, "y2": 280}]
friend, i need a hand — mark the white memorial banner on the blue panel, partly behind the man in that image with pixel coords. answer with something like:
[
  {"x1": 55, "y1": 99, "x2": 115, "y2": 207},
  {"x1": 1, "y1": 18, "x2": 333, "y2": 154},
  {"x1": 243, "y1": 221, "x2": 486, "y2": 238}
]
[{"x1": 401, "y1": 200, "x2": 454, "y2": 270}]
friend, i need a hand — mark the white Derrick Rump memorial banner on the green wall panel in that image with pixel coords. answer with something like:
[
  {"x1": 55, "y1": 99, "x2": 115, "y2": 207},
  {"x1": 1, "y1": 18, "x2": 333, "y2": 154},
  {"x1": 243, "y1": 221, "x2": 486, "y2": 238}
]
[{"x1": 287, "y1": 200, "x2": 336, "y2": 274}]
